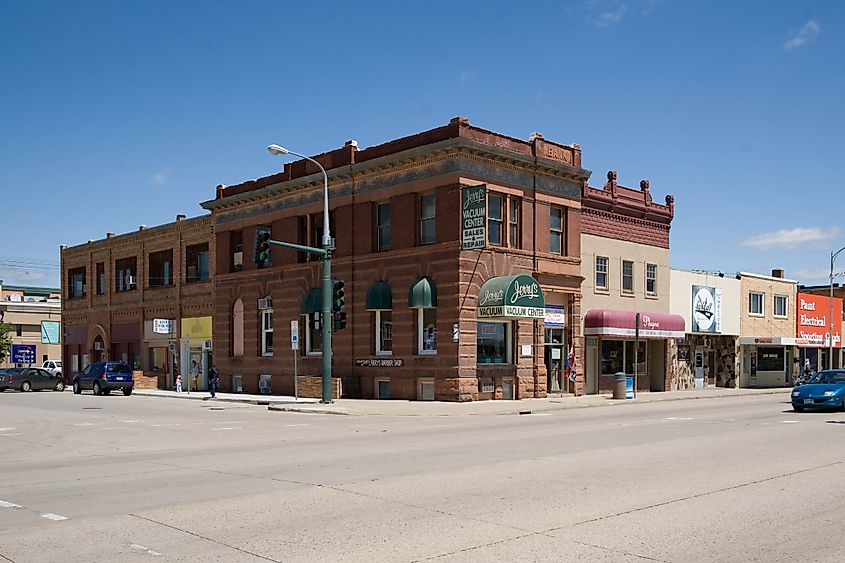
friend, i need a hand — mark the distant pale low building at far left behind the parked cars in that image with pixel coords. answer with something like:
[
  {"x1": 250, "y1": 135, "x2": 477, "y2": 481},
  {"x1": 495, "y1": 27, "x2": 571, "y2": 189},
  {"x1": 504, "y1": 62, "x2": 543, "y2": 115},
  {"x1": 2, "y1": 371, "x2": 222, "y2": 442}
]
[{"x1": 0, "y1": 280, "x2": 62, "y2": 367}]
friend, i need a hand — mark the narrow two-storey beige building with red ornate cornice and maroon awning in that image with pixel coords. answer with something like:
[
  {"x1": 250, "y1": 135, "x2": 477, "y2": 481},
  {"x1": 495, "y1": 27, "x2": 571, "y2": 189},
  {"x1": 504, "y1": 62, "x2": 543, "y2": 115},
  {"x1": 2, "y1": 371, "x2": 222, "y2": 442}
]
[{"x1": 579, "y1": 171, "x2": 684, "y2": 394}]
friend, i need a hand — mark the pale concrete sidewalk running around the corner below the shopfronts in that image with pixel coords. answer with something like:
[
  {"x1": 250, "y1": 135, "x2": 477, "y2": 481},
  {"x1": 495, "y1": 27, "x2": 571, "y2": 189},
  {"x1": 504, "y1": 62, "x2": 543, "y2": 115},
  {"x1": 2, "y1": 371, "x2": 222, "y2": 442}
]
[{"x1": 134, "y1": 387, "x2": 791, "y2": 416}]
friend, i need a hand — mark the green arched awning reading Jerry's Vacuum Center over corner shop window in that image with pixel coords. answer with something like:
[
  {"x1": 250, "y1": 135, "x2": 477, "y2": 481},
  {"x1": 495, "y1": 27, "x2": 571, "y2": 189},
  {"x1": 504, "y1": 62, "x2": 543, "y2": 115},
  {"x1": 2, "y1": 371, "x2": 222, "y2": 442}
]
[{"x1": 476, "y1": 274, "x2": 546, "y2": 319}]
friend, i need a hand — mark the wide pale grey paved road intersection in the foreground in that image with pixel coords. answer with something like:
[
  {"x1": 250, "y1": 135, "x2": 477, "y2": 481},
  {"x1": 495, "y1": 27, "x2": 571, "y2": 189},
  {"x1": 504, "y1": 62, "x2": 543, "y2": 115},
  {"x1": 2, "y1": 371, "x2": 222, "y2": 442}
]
[{"x1": 0, "y1": 392, "x2": 845, "y2": 563}]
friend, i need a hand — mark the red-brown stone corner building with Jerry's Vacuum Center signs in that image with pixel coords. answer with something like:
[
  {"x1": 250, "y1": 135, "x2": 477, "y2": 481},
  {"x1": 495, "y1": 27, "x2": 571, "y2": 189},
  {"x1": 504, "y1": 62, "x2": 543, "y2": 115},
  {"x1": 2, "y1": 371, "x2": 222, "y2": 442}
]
[{"x1": 204, "y1": 118, "x2": 589, "y2": 401}]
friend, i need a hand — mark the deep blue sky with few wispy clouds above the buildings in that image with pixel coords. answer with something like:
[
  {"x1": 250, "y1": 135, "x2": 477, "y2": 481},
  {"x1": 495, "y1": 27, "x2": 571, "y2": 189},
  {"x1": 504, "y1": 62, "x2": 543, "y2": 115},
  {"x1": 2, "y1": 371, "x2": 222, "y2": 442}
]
[{"x1": 0, "y1": 0, "x2": 845, "y2": 285}]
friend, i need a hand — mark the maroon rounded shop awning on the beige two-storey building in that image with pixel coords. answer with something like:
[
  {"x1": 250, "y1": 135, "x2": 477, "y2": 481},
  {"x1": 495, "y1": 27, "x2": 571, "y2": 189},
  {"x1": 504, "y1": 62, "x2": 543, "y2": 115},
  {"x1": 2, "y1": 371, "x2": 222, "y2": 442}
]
[{"x1": 584, "y1": 309, "x2": 686, "y2": 338}]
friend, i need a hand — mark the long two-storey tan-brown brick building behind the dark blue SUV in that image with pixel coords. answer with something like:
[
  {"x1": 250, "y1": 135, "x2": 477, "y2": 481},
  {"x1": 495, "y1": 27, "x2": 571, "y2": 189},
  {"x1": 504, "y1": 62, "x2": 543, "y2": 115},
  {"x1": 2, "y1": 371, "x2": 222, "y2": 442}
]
[{"x1": 61, "y1": 215, "x2": 215, "y2": 388}]
